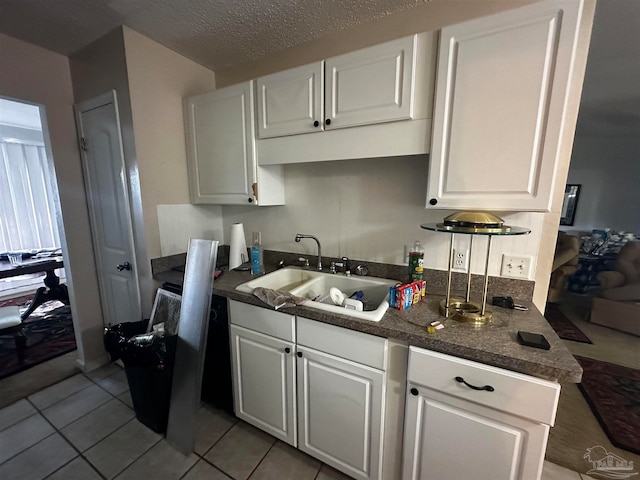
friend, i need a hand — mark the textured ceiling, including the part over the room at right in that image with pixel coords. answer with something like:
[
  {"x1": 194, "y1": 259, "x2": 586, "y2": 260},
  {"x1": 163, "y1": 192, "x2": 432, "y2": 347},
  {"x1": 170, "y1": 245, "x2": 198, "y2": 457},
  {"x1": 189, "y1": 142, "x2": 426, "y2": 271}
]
[{"x1": 0, "y1": 0, "x2": 640, "y2": 137}]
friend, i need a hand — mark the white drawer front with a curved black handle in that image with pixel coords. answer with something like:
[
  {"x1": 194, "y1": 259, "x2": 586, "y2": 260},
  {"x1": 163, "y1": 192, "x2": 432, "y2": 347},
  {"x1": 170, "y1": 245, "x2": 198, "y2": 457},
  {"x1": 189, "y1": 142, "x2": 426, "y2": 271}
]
[{"x1": 407, "y1": 347, "x2": 560, "y2": 426}]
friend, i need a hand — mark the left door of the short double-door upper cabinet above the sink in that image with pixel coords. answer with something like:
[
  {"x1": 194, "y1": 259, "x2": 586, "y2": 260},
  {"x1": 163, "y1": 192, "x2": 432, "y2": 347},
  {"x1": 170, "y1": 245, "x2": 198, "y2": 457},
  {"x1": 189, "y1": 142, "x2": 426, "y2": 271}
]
[{"x1": 257, "y1": 62, "x2": 324, "y2": 138}]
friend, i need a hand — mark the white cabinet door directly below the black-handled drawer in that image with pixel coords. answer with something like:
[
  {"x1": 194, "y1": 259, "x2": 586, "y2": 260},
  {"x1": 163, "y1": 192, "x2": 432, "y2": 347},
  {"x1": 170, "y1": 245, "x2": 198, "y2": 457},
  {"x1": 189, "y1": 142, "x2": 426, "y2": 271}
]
[{"x1": 402, "y1": 384, "x2": 549, "y2": 480}]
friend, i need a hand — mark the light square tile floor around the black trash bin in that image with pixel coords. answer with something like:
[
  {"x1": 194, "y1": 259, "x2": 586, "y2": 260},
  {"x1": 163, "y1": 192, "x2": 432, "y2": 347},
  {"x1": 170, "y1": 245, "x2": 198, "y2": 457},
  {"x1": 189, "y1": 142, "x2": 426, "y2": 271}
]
[{"x1": 0, "y1": 365, "x2": 589, "y2": 480}]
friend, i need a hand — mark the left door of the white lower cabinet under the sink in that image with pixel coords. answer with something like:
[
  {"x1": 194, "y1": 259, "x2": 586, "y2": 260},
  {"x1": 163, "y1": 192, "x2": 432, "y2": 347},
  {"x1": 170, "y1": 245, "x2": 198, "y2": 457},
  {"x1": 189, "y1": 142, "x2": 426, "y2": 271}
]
[{"x1": 230, "y1": 325, "x2": 296, "y2": 446}]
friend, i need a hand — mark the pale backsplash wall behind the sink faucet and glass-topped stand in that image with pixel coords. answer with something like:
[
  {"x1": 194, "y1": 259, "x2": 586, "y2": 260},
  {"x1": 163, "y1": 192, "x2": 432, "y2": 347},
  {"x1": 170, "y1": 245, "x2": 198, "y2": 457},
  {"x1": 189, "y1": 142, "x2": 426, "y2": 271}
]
[{"x1": 218, "y1": 155, "x2": 543, "y2": 279}]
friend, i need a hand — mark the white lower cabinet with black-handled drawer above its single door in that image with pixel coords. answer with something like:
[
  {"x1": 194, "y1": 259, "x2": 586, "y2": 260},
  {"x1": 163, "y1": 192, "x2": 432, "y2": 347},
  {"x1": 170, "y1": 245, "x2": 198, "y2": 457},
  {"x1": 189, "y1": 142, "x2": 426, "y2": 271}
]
[{"x1": 402, "y1": 347, "x2": 560, "y2": 480}]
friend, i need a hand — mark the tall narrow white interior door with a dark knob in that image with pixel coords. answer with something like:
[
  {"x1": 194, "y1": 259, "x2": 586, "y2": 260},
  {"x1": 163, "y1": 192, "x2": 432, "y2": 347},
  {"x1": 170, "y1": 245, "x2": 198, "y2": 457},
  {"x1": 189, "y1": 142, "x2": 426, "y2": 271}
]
[{"x1": 75, "y1": 91, "x2": 142, "y2": 326}]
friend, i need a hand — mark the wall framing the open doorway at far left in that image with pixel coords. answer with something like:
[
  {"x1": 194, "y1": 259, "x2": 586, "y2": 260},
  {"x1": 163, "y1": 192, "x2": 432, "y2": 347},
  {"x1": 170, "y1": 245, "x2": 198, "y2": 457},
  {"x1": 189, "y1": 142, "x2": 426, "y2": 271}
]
[{"x1": 0, "y1": 34, "x2": 104, "y2": 368}]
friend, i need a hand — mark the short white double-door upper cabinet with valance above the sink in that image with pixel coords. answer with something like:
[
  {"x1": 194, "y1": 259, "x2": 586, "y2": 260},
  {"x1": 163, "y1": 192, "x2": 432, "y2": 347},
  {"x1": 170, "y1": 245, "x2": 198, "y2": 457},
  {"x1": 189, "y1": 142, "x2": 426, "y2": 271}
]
[{"x1": 257, "y1": 33, "x2": 436, "y2": 165}]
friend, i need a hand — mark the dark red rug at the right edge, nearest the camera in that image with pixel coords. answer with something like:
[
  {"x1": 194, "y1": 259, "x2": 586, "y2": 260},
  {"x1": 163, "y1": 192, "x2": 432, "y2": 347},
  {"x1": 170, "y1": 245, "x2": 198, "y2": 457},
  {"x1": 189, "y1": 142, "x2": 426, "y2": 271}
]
[{"x1": 576, "y1": 356, "x2": 640, "y2": 454}]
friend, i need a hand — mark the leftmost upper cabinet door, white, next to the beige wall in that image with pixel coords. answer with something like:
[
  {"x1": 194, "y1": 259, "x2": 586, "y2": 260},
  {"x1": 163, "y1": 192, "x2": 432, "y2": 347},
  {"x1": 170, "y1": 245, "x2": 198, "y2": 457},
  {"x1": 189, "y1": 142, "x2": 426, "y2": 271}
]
[{"x1": 185, "y1": 81, "x2": 256, "y2": 205}]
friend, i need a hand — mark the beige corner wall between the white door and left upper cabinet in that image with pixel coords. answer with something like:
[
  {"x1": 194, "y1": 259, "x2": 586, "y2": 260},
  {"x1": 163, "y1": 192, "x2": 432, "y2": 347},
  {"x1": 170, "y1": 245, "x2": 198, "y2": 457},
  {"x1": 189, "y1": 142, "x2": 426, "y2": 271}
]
[{"x1": 71, "y1": 26, "x2": 220, "y2": 317}]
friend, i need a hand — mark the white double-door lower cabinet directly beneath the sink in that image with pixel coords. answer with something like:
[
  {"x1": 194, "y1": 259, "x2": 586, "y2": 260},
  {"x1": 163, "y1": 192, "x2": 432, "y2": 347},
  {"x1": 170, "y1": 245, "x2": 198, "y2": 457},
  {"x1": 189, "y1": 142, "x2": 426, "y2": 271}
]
[{"x1": 229, "y1": 300, "x2": 407, "y2": 480}]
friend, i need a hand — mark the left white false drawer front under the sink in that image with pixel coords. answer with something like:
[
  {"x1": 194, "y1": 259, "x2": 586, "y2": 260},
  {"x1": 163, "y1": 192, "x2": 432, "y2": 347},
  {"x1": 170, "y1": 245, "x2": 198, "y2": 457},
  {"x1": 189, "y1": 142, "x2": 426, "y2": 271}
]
[{"x1": 229, "y1": 300, "x2": 296, "y2": 342}]
